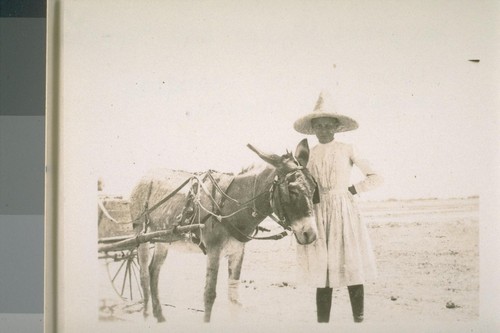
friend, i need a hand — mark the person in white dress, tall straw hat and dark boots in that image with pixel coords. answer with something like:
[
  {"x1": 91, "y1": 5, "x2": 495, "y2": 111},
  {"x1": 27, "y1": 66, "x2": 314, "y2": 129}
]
[{"x1": 294, "y1": 93, "x2": 382, "y2": 322}]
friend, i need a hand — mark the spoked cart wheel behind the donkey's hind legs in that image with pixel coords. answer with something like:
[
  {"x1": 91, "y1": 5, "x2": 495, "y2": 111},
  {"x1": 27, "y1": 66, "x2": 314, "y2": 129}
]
[{"x1": 106, "y1": 249, "x2": 142, "y2": 301}]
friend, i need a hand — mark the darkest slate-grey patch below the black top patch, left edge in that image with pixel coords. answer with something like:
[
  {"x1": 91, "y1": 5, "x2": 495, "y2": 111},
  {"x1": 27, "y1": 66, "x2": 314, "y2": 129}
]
[{"x1": 0, "y1": 17, "x2": 47, "y2": 116}]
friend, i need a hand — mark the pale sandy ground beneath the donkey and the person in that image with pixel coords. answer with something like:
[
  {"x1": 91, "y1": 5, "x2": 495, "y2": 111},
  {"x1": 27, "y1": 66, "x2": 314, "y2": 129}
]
[{"x1": 99, "y1": 198, "x2": 479, "y2": 327}]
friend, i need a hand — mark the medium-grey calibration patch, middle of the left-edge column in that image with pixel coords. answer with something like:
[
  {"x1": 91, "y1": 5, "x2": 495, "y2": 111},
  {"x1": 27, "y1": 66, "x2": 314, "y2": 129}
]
[{"x1": 0, "y1": 116, "x2": 45, "y2": 214}]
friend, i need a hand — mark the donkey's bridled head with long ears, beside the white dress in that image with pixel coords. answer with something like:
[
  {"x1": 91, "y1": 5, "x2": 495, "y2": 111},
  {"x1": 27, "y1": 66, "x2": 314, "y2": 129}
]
[{"x1": 248, "y1": 139, "x2": 318, "y2": 244}]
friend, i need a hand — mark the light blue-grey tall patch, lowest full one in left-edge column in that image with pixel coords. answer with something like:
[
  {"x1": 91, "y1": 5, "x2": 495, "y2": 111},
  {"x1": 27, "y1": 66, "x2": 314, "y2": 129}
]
[{"x1": 0, "y1": 215, "x2": 44, "y2": 313}]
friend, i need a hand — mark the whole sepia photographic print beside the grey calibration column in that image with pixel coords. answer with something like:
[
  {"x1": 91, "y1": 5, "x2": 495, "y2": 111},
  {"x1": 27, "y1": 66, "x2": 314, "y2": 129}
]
[{"x1": 46, "y1": 0, "x2": 499, "y2": 332}]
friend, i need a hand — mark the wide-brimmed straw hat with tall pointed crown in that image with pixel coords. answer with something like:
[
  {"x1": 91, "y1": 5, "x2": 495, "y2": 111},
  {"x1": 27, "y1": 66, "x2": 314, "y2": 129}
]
[{"x1": 293, "y1": 91, "x2": 359, "y2": 134}]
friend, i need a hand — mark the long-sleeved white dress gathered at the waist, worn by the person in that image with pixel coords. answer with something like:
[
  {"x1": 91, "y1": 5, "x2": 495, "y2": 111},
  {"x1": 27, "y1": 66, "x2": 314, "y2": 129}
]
[{"x1": 297, "y1": 141, "x2": 382, "y2": 288}]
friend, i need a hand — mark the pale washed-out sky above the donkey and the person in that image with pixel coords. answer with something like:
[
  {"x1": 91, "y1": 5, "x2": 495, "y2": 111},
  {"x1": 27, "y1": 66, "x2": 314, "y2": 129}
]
[{"x1": 62, "y1": 0, "x2": 500, "y2": 199}]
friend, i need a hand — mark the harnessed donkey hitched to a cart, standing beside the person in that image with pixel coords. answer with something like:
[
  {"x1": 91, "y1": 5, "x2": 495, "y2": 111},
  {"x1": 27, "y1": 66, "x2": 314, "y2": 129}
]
[{"x1": 130, "y1": 139, "x2": 317, "y2": 322}]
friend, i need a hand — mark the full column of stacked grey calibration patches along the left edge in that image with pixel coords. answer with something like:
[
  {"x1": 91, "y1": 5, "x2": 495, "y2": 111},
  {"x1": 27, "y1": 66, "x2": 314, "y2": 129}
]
[{"x1": 0, "y1": 13, "x2": 46, "y2": 322}]
